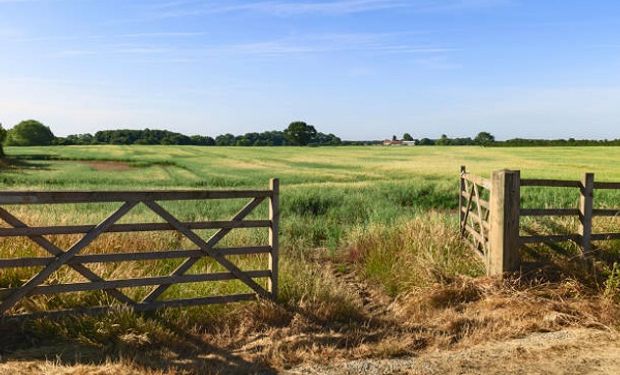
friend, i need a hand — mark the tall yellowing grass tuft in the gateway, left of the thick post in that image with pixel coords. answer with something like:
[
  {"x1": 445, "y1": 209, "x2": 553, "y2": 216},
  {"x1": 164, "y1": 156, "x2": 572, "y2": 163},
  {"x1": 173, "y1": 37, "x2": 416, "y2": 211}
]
[{"x1": 347, "y1": 212, "x2": 484, "y2": 297}]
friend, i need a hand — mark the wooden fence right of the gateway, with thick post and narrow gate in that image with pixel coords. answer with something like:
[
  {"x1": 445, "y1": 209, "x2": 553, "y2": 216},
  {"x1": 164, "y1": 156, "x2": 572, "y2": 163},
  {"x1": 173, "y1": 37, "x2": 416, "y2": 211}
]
[{"x1": 459, "y1": 166, "x2": 620, "y2": 275}]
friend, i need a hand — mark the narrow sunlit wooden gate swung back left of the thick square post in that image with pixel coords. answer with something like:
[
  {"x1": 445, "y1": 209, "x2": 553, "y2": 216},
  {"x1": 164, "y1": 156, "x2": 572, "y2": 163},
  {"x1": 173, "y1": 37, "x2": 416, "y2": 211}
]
[{"x1": 459, "y1": 167, "x2": 491, "y2": 260}]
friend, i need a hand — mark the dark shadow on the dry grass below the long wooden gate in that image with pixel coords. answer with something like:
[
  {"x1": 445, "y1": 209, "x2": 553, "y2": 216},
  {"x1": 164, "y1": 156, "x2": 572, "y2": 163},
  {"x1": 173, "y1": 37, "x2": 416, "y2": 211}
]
[{"x1": 0, "y1": 313, "x2": 277, "y2": 374}]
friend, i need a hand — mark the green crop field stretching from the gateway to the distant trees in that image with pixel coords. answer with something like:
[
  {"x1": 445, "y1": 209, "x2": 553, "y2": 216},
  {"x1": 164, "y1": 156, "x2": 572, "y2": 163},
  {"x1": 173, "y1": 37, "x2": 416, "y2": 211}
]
[{"x1": 0, "y1": 146, "x2": 620, "y2": 293}]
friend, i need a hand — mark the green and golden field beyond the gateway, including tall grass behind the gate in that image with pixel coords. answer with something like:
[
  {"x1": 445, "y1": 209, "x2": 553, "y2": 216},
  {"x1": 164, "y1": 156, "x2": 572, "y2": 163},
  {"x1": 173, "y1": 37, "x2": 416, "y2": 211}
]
[{"x1": 0, "y1": 146, "x2": 620, "y2": 374}]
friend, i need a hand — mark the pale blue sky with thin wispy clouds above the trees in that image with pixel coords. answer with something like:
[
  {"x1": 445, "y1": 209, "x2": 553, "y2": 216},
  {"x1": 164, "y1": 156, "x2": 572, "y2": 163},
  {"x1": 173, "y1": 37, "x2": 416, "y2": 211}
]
[{"x1": 0, "y1": 0, "x2": 620, "y2": 139}]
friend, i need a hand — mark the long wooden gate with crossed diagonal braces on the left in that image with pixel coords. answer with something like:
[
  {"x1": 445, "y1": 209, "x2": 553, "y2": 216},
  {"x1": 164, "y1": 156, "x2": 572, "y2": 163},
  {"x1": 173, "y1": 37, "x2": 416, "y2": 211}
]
[{"x1": 0, "y1": 179, "x2": 279, "y2": 316}]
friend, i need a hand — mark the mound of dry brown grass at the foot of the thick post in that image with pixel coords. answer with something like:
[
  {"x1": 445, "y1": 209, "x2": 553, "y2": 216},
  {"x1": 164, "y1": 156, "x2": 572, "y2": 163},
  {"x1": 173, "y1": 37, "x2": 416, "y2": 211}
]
[{"x1": 394, "y1": 278, "x2": 620, "y2": 348}]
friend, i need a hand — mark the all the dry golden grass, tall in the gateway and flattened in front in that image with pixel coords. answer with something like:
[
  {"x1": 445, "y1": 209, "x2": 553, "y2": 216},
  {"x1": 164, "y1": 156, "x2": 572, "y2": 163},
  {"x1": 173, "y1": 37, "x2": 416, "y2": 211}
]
[{"x1": 0, "y1": 212, "x2": 620, "y2": 374}]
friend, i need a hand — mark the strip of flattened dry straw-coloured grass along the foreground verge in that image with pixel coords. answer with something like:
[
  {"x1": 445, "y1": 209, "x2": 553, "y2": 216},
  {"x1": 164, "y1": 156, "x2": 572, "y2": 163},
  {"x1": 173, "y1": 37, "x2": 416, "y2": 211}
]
[{"x1": 0, "y1": 278, "x2": 620, "y2": 374}]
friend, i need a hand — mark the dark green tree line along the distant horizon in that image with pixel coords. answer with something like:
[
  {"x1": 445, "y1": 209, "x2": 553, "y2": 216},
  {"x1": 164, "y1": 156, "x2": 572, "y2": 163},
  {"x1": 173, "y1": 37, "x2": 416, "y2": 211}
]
[{"x1": 0, "y1": 120, "x2": 620, "y2": 157}]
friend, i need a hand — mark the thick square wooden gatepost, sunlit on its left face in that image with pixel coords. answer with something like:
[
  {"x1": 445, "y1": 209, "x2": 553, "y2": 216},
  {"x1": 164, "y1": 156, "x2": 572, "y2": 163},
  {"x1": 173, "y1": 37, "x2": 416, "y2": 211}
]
[{"x1": 487, "y1": 170, "x2": 521, "y2": 275}]
